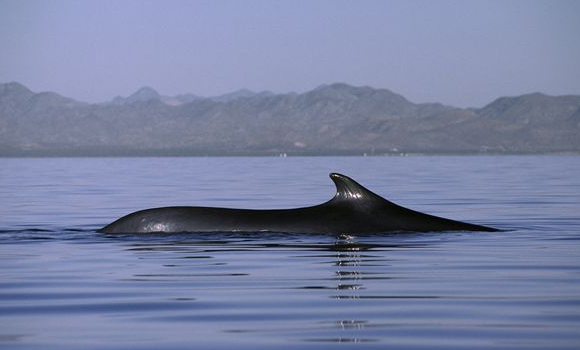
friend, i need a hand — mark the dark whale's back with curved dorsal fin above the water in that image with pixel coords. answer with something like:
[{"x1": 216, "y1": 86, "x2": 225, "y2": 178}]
[{"x1": 98, "y1": 173, "x2": 499, "y2": 235}]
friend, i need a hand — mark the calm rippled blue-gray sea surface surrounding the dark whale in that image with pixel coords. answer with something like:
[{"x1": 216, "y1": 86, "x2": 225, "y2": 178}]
[{"x1": 0, "y1": 156, "x2": 580, "y2": 350}]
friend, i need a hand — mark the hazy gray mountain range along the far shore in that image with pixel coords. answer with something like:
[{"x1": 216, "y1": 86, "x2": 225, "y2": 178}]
[{"x1": 0, "y1": 83, "x2": 580, "y2": 156}]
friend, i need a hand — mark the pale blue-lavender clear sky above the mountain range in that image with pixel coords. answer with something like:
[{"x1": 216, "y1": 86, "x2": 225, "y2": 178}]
[{"x1": 0, "y1": 0, "x2": 580, "y2": 107}]
